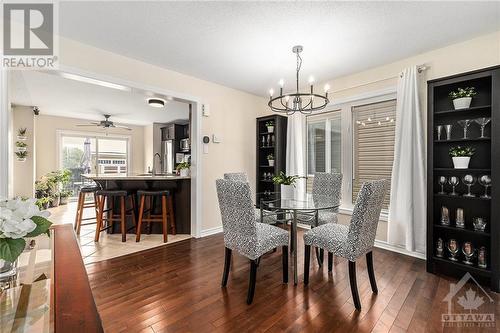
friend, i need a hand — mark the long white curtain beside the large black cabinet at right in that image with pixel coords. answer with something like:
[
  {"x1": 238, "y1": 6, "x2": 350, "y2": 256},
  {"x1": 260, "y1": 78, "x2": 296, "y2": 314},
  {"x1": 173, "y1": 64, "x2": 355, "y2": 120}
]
[{"x1": 388, "y1": 66, "x2": 426, "y2": 253}]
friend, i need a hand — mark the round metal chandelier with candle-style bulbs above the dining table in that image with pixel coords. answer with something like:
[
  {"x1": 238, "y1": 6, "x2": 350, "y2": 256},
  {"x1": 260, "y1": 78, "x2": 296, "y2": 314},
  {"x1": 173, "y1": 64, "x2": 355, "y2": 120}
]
[{"x1": 267, "y1": 45, "x2": 330, "y2": 115}]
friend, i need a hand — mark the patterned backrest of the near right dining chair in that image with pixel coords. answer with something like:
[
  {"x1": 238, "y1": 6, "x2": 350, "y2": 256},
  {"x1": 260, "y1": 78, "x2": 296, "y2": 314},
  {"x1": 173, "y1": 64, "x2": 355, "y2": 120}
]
[{"x1": 347, "y1": 179, "x2": 389, "y2": 260}]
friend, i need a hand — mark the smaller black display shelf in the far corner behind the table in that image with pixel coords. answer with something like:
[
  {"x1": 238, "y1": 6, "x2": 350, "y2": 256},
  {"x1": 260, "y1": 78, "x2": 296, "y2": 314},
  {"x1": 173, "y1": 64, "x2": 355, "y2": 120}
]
[{"x1": 255, "y1": 115, "x2": 288, "y2": 202}]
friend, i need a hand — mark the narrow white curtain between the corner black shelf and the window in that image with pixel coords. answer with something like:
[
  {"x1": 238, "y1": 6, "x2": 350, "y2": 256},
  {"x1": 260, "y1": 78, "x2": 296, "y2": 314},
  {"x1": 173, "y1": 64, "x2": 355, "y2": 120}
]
[{"x1": 286, "y1": 112, "x2": 306, "y2": 192}]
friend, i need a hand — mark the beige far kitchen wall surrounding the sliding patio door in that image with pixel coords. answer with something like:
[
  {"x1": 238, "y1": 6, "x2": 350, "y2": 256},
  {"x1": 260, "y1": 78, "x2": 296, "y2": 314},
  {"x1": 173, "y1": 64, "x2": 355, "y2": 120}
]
[{"x1": 35, "y1": 114, "x2": 144, "y2": 179}]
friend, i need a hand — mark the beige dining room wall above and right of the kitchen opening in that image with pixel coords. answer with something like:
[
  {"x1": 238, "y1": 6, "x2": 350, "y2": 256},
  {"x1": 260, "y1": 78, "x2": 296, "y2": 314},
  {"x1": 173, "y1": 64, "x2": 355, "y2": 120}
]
[{"x1": 60, "y1": 38, "x2": 266, "y2": 230}]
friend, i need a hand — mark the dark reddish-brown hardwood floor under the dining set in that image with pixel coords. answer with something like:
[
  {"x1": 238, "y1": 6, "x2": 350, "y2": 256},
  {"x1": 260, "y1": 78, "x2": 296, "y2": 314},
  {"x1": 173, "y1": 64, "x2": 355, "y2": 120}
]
[{"x1": 87, "y1": 234, "x2": 500, "y2": 333}]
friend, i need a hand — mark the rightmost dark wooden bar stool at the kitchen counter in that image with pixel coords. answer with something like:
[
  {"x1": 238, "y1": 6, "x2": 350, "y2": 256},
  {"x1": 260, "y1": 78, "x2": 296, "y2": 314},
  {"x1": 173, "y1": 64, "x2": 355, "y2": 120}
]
[{"x1": 135, "y1": 190, "x2": 175, "y2": 243}]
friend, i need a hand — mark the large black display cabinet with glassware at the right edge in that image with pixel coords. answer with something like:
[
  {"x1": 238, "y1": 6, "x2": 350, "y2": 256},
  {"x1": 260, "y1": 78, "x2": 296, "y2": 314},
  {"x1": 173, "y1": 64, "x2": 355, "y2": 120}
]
[{"x1": 427, "y1": 66, "x2": 500, "y2": 292}]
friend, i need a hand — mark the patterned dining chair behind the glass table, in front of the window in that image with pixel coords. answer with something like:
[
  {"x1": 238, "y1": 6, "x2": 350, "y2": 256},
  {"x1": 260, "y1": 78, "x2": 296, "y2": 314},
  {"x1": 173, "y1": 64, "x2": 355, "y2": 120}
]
[{"x1": 298, "y1": 172, "x2": 342, "y2": 266}]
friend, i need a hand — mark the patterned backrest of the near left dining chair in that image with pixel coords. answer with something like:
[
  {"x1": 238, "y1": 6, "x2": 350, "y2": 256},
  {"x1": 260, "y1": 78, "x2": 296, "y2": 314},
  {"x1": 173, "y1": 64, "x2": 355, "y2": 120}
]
[{"x1": 216, "y1": 179, "x2": 257, "y2": 246}]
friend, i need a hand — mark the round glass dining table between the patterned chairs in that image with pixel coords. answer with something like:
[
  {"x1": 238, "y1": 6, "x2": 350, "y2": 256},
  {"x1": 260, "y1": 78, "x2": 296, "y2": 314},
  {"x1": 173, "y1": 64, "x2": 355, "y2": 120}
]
[{"x1": 256, "y1": 192, "x2": 340, "y2": 284}]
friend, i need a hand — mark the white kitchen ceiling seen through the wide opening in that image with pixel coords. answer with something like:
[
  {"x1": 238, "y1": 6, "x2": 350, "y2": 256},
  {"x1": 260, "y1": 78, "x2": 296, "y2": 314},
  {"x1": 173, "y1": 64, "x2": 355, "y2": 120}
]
[{"x1": 11, "y1": 71, "x2": 189, "y2": 125}]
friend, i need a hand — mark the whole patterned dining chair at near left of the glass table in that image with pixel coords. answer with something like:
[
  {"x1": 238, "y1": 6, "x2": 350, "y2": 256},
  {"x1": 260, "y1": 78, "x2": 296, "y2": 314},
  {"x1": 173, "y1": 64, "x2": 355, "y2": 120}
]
[{"x1": 216, "y1": 179, "x2": 288, "y2": 304}]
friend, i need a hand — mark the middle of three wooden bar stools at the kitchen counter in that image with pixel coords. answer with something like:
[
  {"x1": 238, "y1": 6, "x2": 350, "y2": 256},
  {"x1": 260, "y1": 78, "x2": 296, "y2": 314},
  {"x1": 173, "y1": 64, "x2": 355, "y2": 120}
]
[{"x1": 94, "y1": 190, "x2": 137, "y2": 242}]
